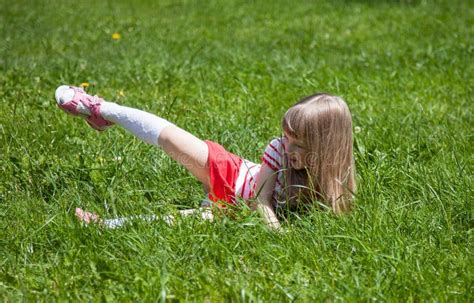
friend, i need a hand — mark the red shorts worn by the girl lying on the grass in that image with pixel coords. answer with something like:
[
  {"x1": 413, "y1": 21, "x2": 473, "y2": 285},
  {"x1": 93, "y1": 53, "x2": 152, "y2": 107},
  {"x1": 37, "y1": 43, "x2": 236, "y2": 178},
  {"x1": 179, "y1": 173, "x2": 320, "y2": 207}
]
[{"x1": 204, "y1": 140, "x2": 242, "y2": 204}]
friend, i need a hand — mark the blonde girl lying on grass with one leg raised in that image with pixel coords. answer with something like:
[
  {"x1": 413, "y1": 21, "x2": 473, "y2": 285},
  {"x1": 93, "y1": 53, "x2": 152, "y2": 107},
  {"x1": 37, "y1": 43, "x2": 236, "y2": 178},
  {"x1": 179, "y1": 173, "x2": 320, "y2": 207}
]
[{"x1": 55, "y1": 85, "x2": 356, "y2": 228}]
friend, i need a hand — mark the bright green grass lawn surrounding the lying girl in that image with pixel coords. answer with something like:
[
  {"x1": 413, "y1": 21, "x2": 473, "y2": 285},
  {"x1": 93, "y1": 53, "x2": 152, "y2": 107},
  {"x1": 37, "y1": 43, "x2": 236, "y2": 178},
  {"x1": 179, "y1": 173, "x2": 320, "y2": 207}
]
[{"x1": 0, "y1": 0, "x2": 474, "y2": 302}]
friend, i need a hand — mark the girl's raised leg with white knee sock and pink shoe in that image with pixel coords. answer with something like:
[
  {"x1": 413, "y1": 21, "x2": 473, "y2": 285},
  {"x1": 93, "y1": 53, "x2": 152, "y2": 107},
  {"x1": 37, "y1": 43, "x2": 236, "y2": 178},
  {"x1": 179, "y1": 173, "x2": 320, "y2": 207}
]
[{"x1": 56, "y1": 86, "x2": 210, "y2": 192}]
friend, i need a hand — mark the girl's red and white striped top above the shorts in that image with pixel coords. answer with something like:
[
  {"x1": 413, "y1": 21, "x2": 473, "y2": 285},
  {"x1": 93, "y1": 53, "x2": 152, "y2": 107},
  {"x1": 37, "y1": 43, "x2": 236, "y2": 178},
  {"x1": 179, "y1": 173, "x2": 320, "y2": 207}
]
[{"x1": 235, "y1": 138, "x2": 285, "y2": 201}]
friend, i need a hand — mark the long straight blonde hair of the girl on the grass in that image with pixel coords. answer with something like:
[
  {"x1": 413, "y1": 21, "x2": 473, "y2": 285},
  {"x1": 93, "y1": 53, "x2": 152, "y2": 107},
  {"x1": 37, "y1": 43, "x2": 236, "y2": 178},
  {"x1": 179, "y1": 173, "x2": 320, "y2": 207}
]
[{"x1": 282, "y1": 93, "x2": 356, "y2": 213}]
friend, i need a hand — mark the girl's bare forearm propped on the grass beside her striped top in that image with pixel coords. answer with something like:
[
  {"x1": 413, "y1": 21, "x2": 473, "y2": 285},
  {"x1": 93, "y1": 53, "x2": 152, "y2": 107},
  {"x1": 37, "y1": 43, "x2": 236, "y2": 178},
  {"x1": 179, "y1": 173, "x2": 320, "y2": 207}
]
[{"x1": 255, "y1": 162, "x2": 280, "y2": 229}]
